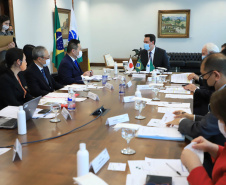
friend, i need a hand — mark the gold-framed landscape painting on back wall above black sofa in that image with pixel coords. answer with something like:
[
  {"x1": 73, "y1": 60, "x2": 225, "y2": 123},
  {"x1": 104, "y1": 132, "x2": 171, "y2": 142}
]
[{"x1": 158, "y1": 10, "x2": 190, "y2": 38}]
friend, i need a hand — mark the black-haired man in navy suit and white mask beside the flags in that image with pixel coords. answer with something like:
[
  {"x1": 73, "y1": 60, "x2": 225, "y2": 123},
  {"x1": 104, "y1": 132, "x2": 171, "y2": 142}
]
[{"x1": 58, "y1": 39, "x2": 93, "y2": 85}]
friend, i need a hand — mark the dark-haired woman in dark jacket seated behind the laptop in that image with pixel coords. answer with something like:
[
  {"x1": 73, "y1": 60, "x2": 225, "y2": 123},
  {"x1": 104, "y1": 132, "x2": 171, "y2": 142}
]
[{"x1": 0, "y1": 48, "x2": 32, "y2": 109}]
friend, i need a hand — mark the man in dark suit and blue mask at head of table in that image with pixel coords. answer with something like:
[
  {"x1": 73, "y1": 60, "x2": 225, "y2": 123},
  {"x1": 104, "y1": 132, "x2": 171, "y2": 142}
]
[{"x1": 140, "y1": 34, "x2": 170, "y2": 70}]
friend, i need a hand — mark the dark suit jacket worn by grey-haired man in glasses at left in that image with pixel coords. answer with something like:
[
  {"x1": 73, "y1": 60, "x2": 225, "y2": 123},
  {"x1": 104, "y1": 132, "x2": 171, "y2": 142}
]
[{"x1": 25, "y1": 63, "x2": 63, "y2": 97}]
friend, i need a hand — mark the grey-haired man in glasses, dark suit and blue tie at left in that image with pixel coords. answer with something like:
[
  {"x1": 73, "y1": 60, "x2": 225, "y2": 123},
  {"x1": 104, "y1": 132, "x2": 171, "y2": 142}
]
[{"x1": 25, "y1": 46, "x2": 63, "y2": 97}]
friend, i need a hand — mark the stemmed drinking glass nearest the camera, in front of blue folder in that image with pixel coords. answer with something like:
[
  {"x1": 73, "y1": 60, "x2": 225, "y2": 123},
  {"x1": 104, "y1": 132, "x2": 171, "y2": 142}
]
[{"x1": 121, "y1": 128, "x2": 136, "y2": 155}]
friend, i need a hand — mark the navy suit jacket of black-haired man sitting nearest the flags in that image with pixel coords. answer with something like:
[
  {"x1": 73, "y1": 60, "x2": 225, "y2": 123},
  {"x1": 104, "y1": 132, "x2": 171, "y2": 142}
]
[{"x1": 58, "y1": 54, "x2": 83, "y2": 85}]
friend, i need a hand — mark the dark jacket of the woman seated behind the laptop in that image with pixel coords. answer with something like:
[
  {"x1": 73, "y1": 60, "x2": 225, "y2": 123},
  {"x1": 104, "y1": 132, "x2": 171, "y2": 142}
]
[{"x1": 0, "y1": 70, "x2": 33, "y2": 109}]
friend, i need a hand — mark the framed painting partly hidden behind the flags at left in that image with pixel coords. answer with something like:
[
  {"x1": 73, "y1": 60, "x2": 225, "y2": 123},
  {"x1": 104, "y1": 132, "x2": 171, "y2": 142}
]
[{"x1": 58, "y1": 8, "x2": 71, "y2": 39}]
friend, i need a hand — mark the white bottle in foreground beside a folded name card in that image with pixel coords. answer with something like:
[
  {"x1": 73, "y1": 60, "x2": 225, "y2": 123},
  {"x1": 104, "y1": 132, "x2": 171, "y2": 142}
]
[{"x1": 77, "y1": 143, "x2": 89, "y2": 177}]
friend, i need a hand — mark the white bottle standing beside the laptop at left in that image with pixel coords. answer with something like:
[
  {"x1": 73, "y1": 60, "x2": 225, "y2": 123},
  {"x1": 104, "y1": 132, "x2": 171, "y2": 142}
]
[{"x1": 17, "y1": 106, "x2": 27, "y2": 135}]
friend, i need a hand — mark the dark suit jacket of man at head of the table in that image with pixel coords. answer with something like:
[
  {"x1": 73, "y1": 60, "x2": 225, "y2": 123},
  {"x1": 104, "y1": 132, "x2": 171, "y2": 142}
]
[{"x1": 140, "y1": 47, "x2": 170, "y2": 70}]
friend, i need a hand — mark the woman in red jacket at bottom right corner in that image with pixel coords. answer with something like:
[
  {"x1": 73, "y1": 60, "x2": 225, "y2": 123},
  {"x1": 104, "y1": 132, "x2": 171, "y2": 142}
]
[{"x1": 181, "y1": 88, "x2": 226, "y2": 185}]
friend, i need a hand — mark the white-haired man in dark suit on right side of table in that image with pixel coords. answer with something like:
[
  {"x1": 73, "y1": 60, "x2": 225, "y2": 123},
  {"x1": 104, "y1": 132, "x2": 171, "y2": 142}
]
[{"x1": 184, "y1": 43, "x2": 219, "y2": 116}]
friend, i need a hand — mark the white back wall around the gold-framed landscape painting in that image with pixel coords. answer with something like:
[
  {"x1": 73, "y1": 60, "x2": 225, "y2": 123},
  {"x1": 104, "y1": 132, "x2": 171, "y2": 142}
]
[{"x1": 89, "y1": 0, "x2": 226, "y2": 62}]
